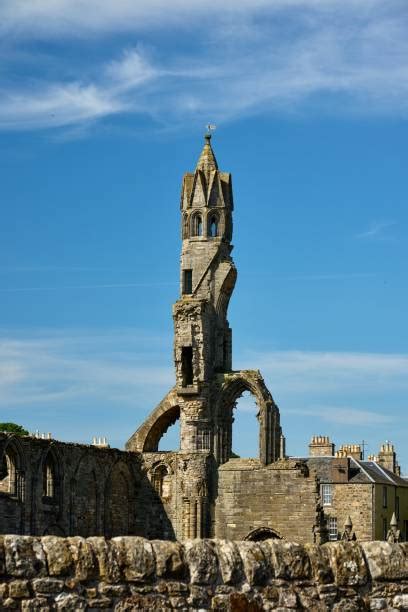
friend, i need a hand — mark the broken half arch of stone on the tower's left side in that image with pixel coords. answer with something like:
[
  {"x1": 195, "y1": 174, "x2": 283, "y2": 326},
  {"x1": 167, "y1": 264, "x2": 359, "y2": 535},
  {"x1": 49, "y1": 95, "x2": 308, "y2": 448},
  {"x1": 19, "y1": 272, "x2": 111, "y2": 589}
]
[{"x1": 126, "y1": 389, "x2": 180, "y2": 453}]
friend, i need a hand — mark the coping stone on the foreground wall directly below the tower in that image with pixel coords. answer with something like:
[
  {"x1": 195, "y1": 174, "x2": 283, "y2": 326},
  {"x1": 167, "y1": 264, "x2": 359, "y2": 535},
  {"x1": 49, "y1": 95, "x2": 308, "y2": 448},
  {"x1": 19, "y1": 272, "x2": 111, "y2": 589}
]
[{"x1": 184, "y1": 540, "x2": 219, "y2": 584}]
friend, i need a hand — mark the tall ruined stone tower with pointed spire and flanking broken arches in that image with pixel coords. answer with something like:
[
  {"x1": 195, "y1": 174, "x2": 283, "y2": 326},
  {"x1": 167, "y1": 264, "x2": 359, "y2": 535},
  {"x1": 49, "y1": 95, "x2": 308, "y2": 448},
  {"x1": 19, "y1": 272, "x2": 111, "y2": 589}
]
[{"x1": 127, "y1": 134, "x2": 284, "y2": 537}]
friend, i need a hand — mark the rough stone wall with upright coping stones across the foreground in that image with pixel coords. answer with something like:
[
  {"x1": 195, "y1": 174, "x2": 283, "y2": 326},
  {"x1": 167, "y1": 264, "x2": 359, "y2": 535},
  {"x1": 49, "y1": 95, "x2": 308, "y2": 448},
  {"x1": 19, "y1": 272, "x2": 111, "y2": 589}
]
[{"x1": 0, "y1": 535, "x2": 408, "y2": 612}]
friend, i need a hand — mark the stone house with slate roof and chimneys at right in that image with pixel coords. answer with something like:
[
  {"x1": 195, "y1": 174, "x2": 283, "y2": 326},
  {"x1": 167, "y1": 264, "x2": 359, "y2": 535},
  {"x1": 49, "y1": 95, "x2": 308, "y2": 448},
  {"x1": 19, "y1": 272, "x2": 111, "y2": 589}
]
[{"x1": 307, "y1": 436, "x2": 408, "y2": 541}]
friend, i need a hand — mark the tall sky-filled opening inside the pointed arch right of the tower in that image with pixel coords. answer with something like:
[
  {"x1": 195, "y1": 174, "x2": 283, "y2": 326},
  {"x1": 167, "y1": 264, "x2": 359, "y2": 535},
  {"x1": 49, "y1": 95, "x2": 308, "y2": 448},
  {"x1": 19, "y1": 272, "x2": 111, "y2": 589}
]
[{"x1": 231, "y1": 391, "x2": 259, "y2": 458}]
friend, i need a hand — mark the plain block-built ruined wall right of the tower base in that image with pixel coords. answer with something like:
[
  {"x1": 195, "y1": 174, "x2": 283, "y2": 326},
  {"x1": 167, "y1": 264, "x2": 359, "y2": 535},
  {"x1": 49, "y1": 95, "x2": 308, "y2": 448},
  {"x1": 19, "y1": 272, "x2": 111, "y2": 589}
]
[{"x1": 214, "y1": 459, "x2": 319, "y2": 542}]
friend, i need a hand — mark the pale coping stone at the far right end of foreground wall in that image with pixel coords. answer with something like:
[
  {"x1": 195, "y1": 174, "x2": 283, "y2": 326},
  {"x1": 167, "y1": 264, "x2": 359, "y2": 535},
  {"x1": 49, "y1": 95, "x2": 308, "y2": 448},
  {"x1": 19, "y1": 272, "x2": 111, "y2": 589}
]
[{"x1": 361, "y1": 542, "x2": 408, "y2": 580}]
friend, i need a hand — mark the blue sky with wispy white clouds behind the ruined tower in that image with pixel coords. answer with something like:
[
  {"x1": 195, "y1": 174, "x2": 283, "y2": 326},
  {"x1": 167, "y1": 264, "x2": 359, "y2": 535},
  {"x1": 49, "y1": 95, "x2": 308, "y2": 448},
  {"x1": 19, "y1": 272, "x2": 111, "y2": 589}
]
[{"x1": 0, "y1": 0, "x2": 408, "y2": 473}]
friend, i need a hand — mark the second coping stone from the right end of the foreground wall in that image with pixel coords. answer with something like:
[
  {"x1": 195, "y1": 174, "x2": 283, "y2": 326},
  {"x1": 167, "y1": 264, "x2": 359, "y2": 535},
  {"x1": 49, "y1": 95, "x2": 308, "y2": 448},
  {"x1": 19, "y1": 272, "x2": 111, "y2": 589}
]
[{"x1": 323, "y1": 542, "x2": 368, "y2": 586}]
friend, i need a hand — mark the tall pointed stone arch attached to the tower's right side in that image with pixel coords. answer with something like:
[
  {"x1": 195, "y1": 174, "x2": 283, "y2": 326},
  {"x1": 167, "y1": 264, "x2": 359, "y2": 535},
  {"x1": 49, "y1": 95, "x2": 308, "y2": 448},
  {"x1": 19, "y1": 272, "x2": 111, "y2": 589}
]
[{"x1": 214, "y1": 370, "x2": 282, "y2": 465}]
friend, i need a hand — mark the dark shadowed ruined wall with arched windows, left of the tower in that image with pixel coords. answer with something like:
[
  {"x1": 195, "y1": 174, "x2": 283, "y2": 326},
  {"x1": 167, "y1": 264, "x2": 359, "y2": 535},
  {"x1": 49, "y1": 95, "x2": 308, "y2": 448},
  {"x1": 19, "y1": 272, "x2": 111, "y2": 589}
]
[{"x1": 0, "y1": 434, "x2": 169, "y2": 538}]
